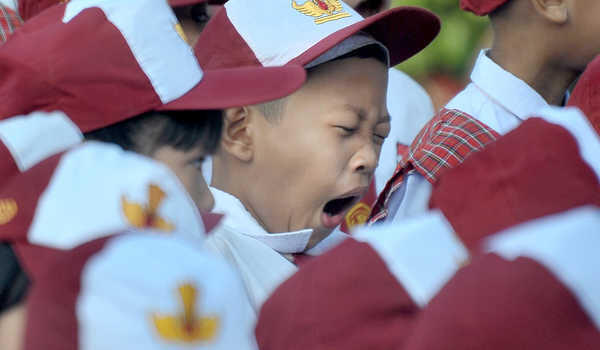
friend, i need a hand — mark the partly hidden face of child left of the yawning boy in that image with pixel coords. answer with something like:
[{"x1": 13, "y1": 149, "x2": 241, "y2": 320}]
[{"x1": 152, "y1": 146, "x2": 214, "y2": 211}]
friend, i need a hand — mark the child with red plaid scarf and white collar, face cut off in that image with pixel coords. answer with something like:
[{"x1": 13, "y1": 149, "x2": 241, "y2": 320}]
[{"x1": 370, "y1": 0, "x2": 600, "y2": 223}]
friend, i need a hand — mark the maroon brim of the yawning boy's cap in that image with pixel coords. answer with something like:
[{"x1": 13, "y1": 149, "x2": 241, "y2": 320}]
[{"x1": 290, "y1": 6, "x2": 441, "y2": 66}]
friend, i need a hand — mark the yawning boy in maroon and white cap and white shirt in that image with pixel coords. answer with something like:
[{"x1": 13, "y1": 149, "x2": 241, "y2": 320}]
[{"x1": 199, "y1": 0, "x2": 439, "y2": 310}]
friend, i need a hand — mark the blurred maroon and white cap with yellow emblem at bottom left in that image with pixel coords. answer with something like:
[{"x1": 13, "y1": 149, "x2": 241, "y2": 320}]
[{"x1": 24, "y1": 230, "x2": 256, "y2": 350}]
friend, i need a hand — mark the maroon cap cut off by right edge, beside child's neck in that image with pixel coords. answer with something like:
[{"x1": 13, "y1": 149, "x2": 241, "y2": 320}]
[{"x1": 567, "y1": 56, "x2": 600, "y2": 135}]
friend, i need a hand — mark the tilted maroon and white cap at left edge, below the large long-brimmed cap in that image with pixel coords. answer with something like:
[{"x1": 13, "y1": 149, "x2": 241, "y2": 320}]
[{"x1": 0, "y1": 142, "x2": 207, "y2": 279}]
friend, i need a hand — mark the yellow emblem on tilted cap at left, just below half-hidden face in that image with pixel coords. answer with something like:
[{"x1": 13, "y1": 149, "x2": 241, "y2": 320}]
[{"x1": 121, "y1": 184, "x2": 175, "y2": 232}]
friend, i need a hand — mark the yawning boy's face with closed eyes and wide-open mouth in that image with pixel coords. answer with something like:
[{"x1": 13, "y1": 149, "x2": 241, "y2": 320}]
[{"x1": 248, "y1": 58, "x2": 390, "y2": 247}]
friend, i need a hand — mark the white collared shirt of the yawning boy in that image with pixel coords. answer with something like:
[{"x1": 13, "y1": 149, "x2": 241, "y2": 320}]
[{"x1": 206, "y1": 187, "x2": 347, "y2": 314}]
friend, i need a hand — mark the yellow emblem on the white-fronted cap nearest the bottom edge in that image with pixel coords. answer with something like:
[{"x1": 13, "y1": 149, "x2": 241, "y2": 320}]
[{"x1": 152, "y1": 283, "x2": 219, "y2": 343}]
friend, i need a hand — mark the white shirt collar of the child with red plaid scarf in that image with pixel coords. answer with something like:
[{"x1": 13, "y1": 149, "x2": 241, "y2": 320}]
[{"x1": 471, "y1": 49, "x2": 548, "y2": 120}]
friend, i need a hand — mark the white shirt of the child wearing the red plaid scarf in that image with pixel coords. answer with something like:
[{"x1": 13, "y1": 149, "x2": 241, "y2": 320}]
[{"x1": 386, "y1": 50, "x2": 548, "y2": 222}]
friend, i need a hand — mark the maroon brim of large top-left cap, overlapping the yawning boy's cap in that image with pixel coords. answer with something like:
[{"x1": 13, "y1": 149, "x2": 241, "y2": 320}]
[{"x1": 157, "y1": 65, "x2": 306, "y2": 110}]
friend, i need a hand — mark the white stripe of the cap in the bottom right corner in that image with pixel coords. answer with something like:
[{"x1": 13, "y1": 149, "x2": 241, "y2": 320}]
[{"x1": 487, "y1": 207, "x2": 600, "y2": 330}]
